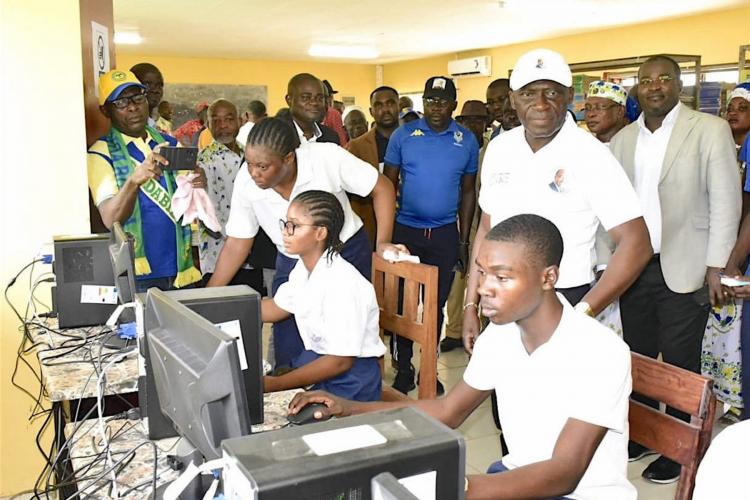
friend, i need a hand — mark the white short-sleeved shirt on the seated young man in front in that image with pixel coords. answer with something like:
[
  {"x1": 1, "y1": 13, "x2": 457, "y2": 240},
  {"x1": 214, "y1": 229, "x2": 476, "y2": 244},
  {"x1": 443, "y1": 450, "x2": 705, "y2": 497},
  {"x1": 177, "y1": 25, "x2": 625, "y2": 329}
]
[{"x1": 464, "y1": 294, "x2": 637, "y2": 500}]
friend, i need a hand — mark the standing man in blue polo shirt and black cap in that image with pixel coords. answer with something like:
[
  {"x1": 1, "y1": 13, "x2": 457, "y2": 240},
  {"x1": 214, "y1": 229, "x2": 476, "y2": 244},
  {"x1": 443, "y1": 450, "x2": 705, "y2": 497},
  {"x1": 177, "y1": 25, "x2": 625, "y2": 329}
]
[{"x1": 384, "y1": 76, "x2": 479, "y2": 394}]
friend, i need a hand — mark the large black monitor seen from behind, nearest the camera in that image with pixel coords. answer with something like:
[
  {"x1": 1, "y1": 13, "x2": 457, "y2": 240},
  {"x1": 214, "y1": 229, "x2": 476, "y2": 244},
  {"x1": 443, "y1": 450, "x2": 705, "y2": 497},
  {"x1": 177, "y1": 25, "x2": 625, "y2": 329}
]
[{"x1": 145, "y1": 288, "x2": 250, "y2": 460}]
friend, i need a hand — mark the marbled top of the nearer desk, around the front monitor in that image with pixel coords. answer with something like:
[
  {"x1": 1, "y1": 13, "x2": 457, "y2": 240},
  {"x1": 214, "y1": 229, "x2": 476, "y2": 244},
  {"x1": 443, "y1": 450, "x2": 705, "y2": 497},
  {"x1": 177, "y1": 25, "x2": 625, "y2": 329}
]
[{"x1": 65, "y1": 389, "x2": 300, "y2": 499}]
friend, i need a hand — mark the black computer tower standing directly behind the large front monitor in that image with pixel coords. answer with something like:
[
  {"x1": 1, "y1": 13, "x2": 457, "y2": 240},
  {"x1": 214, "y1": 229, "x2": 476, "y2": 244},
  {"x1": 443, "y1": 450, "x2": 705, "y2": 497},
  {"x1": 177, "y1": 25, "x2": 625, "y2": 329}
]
[{"x1": 136, "y1": 285, "x2": 263, "y2": 439}]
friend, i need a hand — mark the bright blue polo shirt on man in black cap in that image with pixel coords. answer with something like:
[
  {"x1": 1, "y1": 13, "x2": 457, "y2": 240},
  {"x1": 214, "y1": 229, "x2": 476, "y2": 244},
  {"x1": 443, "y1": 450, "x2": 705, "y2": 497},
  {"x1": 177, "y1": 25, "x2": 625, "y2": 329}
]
[{"x1": 385, "y1": 118, "x2": 479, "y2": 229}]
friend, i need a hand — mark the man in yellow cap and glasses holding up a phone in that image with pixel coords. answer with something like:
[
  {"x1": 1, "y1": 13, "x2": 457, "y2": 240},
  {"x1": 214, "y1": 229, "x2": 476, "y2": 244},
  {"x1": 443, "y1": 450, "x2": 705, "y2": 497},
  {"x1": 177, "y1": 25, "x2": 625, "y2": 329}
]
[{"x1": 87, "y1": 70, "x2": 206, "y2": 292}]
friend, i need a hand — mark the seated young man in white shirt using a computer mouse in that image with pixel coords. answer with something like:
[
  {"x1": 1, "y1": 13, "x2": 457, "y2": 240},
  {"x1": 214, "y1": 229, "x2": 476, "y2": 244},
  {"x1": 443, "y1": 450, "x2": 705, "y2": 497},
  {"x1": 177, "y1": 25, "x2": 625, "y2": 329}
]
[{"x1": 290, "y1": 214, "x2": 636, "y2": 500}]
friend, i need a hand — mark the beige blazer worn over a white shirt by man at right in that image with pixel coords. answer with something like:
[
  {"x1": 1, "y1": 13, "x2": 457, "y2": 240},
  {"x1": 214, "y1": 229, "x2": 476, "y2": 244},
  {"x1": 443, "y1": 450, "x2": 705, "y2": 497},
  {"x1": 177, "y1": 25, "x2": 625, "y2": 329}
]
[{"x1": 610, "y1": 106, "x2": 742, "y2": 293}]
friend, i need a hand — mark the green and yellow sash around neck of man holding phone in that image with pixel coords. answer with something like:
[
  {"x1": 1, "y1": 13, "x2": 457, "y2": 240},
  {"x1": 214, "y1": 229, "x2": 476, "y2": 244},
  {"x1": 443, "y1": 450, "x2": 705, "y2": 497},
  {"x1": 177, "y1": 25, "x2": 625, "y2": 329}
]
[{"x1": 104, "y1": 126, "x2": 201, "y2": 288}]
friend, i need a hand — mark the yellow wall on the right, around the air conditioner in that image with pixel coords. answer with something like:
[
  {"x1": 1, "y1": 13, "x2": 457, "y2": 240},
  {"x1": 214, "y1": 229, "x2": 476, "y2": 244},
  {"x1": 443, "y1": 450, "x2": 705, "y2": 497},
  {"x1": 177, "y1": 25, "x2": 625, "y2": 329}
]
[{"x1": 383, "y1": 7, "x2": 750, "y2": 103}]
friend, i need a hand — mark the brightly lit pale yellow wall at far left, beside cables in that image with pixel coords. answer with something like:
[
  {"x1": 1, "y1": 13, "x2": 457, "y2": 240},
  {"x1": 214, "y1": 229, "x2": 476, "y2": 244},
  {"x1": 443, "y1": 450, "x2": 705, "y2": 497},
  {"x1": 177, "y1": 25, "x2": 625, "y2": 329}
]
[{"x1": 0, "y1": 0, "x2": 89, "y2": 495}]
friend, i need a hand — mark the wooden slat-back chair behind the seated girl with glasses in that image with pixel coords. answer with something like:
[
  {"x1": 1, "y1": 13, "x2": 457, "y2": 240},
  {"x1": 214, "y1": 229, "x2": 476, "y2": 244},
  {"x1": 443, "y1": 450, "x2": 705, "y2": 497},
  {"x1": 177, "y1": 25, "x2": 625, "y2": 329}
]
[{"x1": 372, "y1": 253, "x2": 438, "y2": 401}]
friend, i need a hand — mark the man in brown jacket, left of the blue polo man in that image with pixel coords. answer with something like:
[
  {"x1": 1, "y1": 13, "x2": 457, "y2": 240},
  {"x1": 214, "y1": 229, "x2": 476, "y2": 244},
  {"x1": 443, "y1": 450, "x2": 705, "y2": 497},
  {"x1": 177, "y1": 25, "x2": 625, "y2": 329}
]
[{"x1": 346, "y1": 87, "x2": 398, "y2": 248}]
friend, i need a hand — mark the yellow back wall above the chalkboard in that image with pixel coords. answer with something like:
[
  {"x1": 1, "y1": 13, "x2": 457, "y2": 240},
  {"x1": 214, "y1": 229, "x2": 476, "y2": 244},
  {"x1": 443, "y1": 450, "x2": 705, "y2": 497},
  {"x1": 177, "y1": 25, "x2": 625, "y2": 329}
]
[{"x1": 117, "y1": 51, "x2": 375, "y2": 115}]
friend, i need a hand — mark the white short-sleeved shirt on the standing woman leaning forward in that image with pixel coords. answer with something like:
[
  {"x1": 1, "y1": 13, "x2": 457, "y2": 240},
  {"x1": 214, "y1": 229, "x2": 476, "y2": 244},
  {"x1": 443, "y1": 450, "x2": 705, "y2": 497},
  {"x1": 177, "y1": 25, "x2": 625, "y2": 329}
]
[{"x1": 226, "y1": 143, "x2": 378, "y2": 258}]
